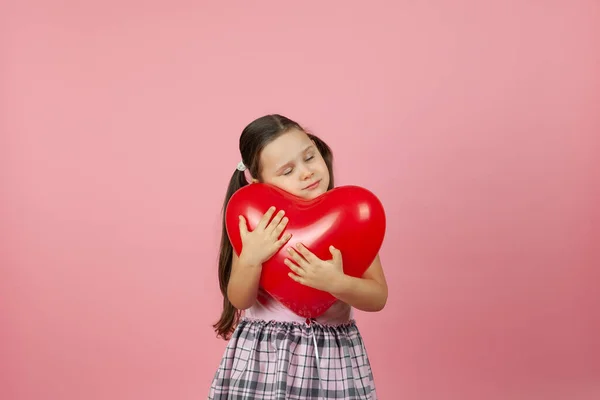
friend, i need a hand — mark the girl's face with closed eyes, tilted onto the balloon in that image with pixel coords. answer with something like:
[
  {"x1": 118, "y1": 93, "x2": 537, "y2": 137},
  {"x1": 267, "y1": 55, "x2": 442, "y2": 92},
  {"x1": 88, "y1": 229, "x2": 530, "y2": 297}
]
[{"x1": 260, "y1": 129, "x2": 329, "y2": 200}]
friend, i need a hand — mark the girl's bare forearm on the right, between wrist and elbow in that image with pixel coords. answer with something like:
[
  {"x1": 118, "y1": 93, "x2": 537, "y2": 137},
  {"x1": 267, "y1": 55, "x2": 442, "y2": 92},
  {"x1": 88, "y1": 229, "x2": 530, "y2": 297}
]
[{"x1": 331, "y1": 275, "x2": 387, "y2": 311}]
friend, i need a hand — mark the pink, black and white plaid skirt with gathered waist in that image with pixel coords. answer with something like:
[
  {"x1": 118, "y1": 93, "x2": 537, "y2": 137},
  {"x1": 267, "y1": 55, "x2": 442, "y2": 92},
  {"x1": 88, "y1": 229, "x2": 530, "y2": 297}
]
[{"x1": 208, "y1": 319, "x2": 377, "y2": 400}]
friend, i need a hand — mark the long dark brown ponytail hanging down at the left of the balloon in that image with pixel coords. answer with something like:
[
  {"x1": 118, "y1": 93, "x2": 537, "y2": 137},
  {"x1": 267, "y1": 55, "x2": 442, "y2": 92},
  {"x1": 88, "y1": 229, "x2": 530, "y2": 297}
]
[{"x1": 213, "y1": 169, "x2": 248, "y2": 340}]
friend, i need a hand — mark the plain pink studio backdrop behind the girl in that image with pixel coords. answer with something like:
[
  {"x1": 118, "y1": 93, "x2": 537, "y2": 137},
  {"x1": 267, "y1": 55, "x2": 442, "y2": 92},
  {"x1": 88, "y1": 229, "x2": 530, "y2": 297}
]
[{"x1": 0, "y1": 0, "x2": 600, "y2": 400}]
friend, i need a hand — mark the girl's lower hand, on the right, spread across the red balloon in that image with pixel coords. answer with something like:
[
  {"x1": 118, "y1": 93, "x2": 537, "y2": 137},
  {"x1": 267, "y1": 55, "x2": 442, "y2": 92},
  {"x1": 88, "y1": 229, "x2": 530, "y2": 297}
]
[{"x1": 285, "y1": 243, "x2": 345, "y2": 293}]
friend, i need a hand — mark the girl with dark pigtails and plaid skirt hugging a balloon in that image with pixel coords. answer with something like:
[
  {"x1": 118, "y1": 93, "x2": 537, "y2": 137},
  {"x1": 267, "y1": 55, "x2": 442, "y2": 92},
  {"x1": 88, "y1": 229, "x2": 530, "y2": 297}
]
[{"x1": 209, "y1": 115, "x2": 387, "y2": 400}]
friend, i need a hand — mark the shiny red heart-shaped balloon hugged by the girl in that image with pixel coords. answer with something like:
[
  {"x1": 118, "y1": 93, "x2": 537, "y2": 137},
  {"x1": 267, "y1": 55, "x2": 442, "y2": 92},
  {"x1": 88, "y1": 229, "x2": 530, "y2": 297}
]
[{"x1": 225, "y1": 183, "x2": 386, "y2": 318}]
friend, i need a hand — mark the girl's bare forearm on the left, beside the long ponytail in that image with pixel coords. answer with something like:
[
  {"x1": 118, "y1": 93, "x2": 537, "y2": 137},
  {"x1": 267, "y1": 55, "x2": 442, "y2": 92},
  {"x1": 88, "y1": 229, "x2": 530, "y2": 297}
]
[{"x1": 227, "y1": 256, "x2": 262, "y2": 310}]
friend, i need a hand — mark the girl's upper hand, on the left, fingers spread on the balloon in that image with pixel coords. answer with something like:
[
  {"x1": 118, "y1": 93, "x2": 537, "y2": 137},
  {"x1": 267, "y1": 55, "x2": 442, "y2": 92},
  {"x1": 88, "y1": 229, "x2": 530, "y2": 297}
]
[{"x1": 240, "y1": 207, "x2": 292, "y2": 266}]
